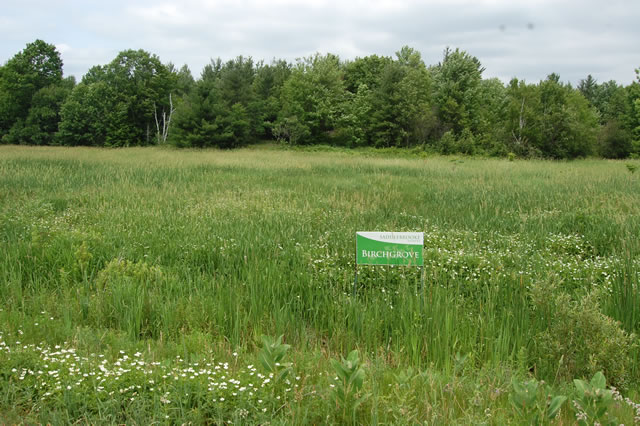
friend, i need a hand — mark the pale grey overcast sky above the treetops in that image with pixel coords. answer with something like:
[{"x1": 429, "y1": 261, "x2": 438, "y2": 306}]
[{"x1": 0, "y1": 0, "x2": 640, "y2": 85}]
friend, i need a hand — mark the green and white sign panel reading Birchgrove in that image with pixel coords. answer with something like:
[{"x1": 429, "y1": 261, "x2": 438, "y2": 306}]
[{"x1": 356, "y1": 232, "x2": 424, "y2": 266}]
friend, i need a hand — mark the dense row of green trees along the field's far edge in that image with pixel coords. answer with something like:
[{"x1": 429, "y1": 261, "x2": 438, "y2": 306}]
[{"x1": 0, "y1": 40, "x2": 640, "y2": 159}]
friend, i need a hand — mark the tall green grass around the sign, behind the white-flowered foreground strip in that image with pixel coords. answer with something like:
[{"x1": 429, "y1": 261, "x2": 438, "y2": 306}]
[{"x1": 0, "y1": 146, "x2": 640, "y2": 422}]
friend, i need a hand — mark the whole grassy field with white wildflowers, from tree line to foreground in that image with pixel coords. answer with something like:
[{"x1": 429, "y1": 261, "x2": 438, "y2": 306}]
[{"x1": 0, "y1": 146, "x2": 640, "y2": 424}]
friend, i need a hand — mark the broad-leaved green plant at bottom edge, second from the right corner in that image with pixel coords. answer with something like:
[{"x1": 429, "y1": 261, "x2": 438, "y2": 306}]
[{"x1": 509, "y1": 378, "x2": 567, "y2": 425}]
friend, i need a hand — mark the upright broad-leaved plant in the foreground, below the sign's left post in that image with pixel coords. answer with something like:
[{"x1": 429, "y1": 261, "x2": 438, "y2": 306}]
[{"x1": 331, "y1": 350, "x2": 370, "y2": 422}]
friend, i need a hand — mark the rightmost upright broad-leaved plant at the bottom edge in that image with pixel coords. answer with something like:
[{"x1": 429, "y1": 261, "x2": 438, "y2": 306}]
[{"x1": 573, "y1": 371, "x2": 618, "y2": 425}]
